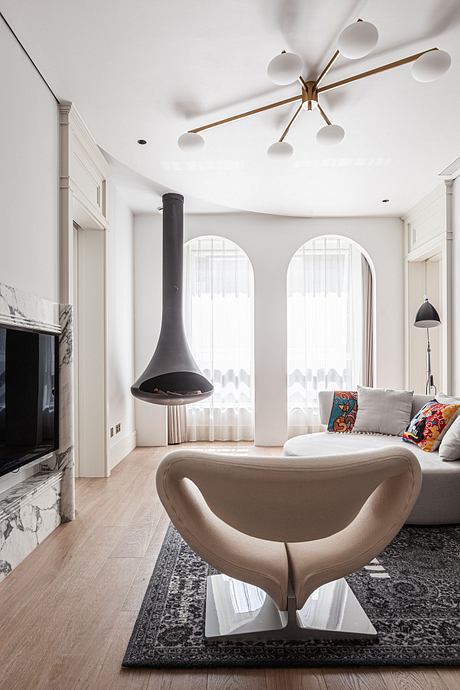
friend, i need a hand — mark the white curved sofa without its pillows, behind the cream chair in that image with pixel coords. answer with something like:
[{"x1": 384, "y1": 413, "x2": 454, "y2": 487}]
[{"x1": 284, "y1": 391, "x2": 460, "y2": 525}]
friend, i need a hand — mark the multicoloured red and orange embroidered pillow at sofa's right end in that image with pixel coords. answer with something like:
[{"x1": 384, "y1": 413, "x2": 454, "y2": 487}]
[{"x1": 403, "y1": 400, "x2": 460, "y2": 453}]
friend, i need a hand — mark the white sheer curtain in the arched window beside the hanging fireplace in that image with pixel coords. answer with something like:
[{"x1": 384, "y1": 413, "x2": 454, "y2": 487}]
[{"x1": 184, "y1": 237, "x2": 254, "y2": 441}]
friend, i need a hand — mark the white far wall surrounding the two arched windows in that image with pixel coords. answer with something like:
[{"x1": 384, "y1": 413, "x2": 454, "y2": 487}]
[{"x1": 135, "y1": 213, "x2": 404, "y2": 445}]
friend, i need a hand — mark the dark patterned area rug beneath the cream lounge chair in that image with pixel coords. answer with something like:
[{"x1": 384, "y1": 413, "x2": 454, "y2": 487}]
[{"x1": 123, "y1": 525, "x2": 460, "y2": 668}]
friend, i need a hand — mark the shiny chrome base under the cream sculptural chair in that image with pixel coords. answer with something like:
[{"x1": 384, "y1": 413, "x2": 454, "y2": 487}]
[{"x1": 205, "y1": 575, "x2": 377, "y2": 641}]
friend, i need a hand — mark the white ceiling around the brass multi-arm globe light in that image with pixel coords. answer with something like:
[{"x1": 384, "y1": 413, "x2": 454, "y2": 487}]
[{"x1": 0, "y1": 0, "x2": 460, "y2": 216}]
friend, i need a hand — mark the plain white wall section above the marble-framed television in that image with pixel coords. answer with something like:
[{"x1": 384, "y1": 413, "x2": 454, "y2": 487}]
[{"x1": 0, "y1": 19, "x2": 59, "y2": 301}]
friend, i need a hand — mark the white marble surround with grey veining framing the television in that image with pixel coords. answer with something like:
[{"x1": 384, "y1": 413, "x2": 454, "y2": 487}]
[{"x1": 0, "y1": 283, "x2": 75, "y2": 580}]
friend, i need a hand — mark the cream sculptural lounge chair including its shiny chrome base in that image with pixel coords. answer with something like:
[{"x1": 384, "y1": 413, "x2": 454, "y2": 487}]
[{"x1": 157, "y1": 446, "x2": 421, "y2": 640}]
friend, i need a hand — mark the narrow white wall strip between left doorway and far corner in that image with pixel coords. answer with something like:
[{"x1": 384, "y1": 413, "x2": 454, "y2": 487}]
[{"x1": 107, "y1": 183, "x2": 136, "y2": 468}]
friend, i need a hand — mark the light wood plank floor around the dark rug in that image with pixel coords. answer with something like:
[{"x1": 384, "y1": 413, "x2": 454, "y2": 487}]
[{"x1": 0, "y1": 444, "x2": 460, "y2": 690}]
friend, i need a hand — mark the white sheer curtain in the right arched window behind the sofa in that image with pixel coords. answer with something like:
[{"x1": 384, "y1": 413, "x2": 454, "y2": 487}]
[{"x1": 288, "y1": 236, "x2": 362, "y2": 436}]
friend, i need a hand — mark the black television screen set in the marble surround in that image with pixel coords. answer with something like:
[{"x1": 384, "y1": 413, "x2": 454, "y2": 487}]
[{"x1": 0, "y1": 326, "x2": 59, "y2": 475}]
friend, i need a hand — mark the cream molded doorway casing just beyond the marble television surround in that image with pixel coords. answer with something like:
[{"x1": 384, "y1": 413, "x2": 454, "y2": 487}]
[{"x1": 58, "y1": 102, "x2": 110, "y2": 477}]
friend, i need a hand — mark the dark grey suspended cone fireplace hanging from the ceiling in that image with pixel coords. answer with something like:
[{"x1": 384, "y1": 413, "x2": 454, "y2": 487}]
[{"x1": 131, "y1": 193, "x2": 214, "y2": 405}]
